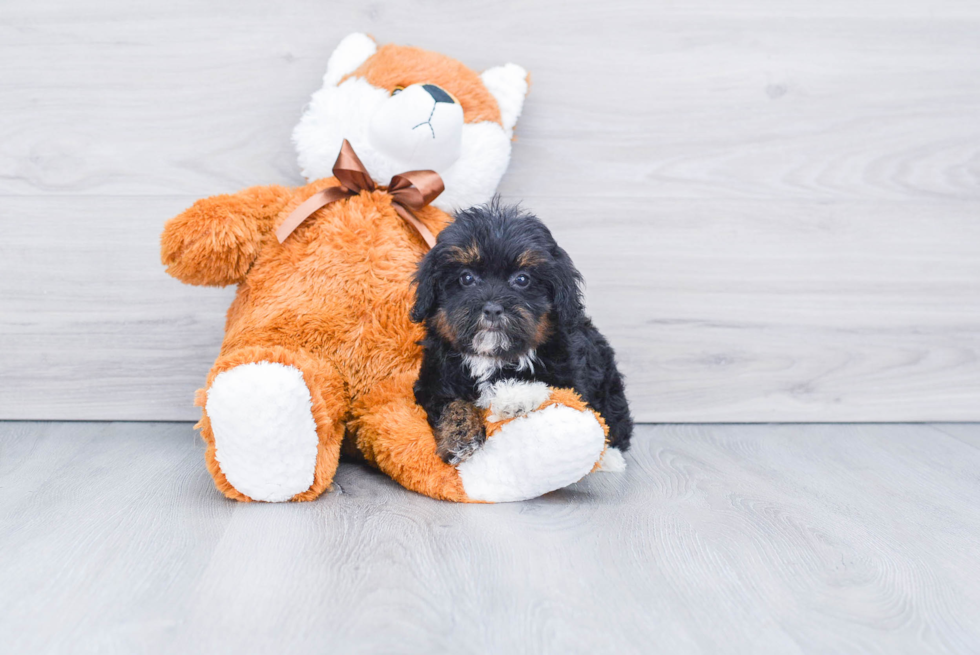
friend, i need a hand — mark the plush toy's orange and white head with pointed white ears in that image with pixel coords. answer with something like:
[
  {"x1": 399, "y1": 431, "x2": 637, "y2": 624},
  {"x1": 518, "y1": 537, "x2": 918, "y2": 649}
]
[{"x1": 293, "y1": 34, "x2": 528, "y2": 211}]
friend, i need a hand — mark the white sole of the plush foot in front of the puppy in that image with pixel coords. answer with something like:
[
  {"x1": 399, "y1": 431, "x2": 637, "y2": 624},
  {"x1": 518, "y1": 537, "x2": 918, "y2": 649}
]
[{"x1": 456, "y1": 405, "x2": 606, "y2": 503}]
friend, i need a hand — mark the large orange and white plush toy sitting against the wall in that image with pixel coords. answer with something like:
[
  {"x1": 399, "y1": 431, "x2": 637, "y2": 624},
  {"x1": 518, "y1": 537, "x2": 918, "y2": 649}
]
[{"x1": 162, "y1": 34, "x2": 621, "y2": 502}]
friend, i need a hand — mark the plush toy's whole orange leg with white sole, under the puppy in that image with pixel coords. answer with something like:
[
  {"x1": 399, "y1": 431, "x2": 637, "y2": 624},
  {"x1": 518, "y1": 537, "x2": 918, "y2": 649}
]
[{"x1": 352, "y1": 373, "x2": 606, "y2": 502}]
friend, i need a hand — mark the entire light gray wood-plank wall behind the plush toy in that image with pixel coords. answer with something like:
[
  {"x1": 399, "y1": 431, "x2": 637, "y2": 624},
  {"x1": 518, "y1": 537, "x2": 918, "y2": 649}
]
[{"x1": 0, "y1": 0, "x2": 980, "y2": 422}]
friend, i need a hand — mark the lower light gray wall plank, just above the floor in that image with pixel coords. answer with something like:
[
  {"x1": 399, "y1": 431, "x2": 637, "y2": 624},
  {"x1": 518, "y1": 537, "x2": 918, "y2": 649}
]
[{"x1": 0, "y1": 196, "x2": 980, "y2": 422}]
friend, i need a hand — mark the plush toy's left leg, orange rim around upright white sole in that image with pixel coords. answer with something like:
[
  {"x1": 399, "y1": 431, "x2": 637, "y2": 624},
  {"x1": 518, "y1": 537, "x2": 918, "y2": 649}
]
[{"x1": 197, "y1": 347, "x2": 349, "y2": 502}]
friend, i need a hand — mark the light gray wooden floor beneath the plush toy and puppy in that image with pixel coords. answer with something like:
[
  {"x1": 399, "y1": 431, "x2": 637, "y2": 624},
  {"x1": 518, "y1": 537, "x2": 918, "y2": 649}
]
[{"x1": 0, "y1": 423, "x2": 980, "y2": 654}]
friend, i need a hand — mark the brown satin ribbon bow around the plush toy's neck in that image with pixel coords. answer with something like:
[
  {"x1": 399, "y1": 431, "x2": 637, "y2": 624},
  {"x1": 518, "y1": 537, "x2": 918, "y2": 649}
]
[{"x1": 276, "y1": 139, "x2": 446, "y2": 248}]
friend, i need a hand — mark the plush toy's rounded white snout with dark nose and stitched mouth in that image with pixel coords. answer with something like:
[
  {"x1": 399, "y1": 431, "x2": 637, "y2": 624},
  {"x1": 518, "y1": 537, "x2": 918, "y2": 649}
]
[{"x1": 368, "y1": 84, "x2": 463, "y2": 172}]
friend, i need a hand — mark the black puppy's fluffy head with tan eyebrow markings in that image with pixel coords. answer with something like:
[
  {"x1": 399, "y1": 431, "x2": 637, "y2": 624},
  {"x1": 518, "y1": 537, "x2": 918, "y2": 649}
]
[{"x1": 412, "y1": 202, "x2": 582, "y2": 359}]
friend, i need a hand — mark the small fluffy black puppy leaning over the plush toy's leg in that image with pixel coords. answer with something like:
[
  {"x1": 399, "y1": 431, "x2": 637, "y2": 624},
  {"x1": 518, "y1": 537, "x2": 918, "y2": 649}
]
[{"x1": 412, "y1": 201, "x2": 633, "y2": 465}]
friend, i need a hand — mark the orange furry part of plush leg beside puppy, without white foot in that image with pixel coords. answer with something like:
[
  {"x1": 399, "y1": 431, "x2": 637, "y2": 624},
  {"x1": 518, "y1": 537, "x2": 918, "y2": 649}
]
[{"x1": 351, "y1": 372, "x2": 470, "y2": 502}]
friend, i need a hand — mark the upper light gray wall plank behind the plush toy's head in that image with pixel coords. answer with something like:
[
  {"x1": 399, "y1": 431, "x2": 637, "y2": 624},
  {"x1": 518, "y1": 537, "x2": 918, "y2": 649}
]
[{"x1": 0, "y1": 0, "x2": 980, "y2": 201}]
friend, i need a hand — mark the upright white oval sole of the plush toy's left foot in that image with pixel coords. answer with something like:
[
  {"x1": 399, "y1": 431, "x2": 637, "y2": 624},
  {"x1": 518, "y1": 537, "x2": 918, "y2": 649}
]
[{"x1": 205, "y1": 362, "x2": 318, "y2": 502}]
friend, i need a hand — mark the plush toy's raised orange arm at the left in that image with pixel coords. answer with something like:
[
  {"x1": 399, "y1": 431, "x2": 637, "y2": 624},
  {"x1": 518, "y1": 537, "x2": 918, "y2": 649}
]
[{"x1": 160, "y1": 186, "x2": 293, "y2": 286}]
